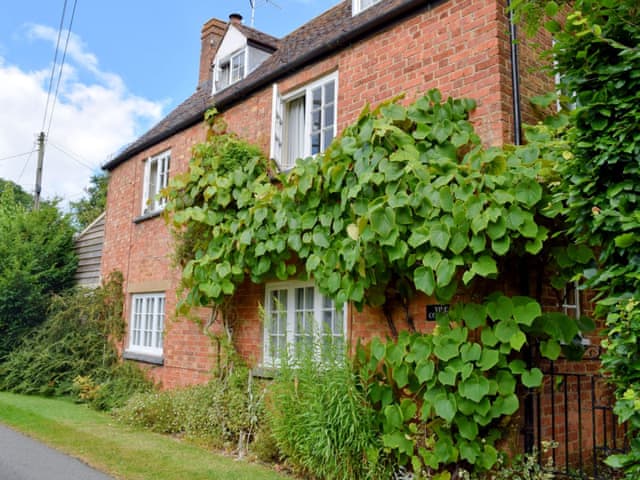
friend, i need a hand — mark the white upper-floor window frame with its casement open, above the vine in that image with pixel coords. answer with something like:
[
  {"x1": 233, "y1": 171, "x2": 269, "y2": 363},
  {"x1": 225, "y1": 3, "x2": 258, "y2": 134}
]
[{"x1": 271, "y1": 72, "x2": 339, "y2": 170}]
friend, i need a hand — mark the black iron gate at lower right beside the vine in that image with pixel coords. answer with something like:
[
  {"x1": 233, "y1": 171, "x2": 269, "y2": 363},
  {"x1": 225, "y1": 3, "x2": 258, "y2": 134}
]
[{"x1": 525, "y1": 346, "x2": 627, "y2": 480}]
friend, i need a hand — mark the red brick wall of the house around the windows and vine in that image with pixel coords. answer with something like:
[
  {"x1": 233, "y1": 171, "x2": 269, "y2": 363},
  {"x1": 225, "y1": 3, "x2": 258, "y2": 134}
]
[{"x1": 103, "y1": 0, "x2": 556, "y2": 387}]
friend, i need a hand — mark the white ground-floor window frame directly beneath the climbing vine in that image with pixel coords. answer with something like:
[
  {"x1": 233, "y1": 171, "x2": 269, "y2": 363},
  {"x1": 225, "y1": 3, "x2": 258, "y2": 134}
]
[{"x1": 263, "y1": 280, "x2": 347, "y2": 367}]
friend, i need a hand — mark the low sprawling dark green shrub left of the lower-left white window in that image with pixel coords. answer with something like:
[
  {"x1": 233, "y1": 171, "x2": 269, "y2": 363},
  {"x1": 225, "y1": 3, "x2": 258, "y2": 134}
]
[{"x1": 0, "y1": 275, "x2": 150, "y2": 409}]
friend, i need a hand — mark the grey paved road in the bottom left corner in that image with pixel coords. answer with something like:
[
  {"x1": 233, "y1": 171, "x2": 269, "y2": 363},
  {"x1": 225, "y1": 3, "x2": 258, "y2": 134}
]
[{"x1": 0, "y1": 425, "x2": 113, "y2": 480}]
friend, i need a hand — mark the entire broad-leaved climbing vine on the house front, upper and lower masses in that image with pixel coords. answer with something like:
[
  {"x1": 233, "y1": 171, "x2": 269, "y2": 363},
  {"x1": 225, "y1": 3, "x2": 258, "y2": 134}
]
[{"x1": 166, "y1": 90, "x2": 590, "y2": 479}]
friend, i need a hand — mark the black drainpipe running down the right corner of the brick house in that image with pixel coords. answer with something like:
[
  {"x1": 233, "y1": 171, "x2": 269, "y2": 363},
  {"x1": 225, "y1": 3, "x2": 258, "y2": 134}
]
[{"x1": 507, "y1": 0, "x2": 535, "y2": 453}]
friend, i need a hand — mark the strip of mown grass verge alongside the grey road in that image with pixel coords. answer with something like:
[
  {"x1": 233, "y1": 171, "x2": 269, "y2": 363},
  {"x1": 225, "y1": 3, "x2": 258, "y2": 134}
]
[{"x1": 0, "y1": 392, "x2": 289, "y2": 480}]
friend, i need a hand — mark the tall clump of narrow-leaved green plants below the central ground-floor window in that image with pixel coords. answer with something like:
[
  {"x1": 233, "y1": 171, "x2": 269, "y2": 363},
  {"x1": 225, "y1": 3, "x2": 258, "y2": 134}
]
[{"x1": 268, "y1": 349, "x2": 389, "y2": 480}]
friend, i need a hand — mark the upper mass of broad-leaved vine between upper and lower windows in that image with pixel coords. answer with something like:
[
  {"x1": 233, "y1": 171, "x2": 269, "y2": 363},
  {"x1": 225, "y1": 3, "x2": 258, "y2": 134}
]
[{"x1": 166, "y1": 90, "x2": 548, "y2": 318}]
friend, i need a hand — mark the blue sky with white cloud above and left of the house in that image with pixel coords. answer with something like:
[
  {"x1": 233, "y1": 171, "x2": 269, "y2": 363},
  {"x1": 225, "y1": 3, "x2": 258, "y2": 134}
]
[{"x1": 0, "y1": 0, "x2": 339, "y2": 208}]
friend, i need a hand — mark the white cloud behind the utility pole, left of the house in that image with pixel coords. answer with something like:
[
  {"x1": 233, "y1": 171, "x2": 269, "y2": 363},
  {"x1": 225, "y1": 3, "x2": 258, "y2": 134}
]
[{"x1": 0, "y1": 25, "x2": 166, "y2": 207}]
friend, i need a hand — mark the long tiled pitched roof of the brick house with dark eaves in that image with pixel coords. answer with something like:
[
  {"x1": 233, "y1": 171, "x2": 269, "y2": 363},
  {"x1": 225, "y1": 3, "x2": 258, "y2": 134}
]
[{"x1": 103, "y1": 0, "x2": 430, "y2": 170}]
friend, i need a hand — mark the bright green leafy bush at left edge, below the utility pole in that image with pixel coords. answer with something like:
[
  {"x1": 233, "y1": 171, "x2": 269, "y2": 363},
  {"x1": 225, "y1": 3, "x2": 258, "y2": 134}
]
[{"x1": 0, "y1": 188, "x2": 77, "y2": 362}]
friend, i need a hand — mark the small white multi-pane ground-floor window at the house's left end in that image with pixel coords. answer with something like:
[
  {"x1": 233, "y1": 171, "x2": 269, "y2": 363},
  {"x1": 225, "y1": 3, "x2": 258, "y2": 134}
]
[{"x1": 127, "y1": 293, "x2": 166, "y2": 357}]
